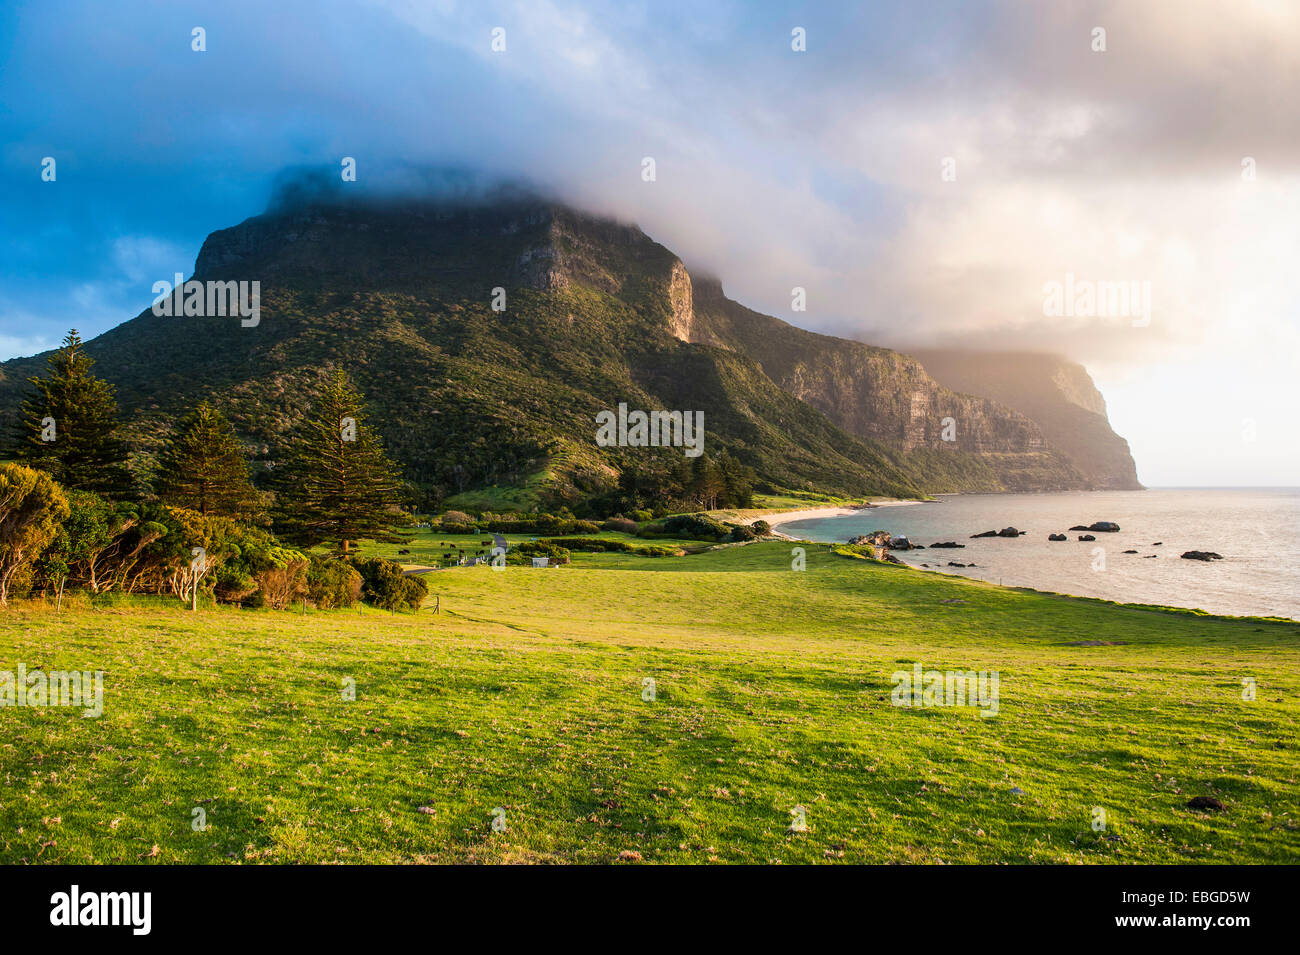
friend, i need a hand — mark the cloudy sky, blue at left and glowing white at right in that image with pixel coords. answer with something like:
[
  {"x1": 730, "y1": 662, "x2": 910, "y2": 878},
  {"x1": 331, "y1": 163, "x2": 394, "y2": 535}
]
[{"x1": 0, "y1": 0, "x2": 1300, "y2": 486}]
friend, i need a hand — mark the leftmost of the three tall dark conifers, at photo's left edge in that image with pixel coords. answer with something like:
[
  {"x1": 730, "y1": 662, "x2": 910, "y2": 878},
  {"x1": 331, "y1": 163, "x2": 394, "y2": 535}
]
[{"x1": 14, "y1": 329, "x2": 131, "y2": 498}]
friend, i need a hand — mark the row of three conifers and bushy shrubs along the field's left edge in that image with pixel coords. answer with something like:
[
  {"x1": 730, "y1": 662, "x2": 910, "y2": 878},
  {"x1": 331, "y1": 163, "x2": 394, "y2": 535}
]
[{"x1": 0, "y1": 329, "x2": 425, "y2": 607}]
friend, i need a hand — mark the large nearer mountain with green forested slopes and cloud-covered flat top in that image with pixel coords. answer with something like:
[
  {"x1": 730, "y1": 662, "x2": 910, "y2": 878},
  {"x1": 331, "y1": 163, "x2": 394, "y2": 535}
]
[{"x1": 0, "y1": 194, "x2": 1138, "y2": 504}]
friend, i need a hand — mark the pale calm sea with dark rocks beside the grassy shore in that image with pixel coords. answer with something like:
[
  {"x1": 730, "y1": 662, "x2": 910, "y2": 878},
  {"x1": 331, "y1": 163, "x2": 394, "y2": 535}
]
[{"x1": 779, "y1": 487, "x2": 1300, "y2": 618}]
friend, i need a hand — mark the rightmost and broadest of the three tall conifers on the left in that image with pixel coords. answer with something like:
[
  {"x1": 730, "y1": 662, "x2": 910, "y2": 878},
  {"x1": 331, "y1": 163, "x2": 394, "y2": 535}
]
[{"x1": 276, "y1": 372, "x2": 406, "y2": 555}]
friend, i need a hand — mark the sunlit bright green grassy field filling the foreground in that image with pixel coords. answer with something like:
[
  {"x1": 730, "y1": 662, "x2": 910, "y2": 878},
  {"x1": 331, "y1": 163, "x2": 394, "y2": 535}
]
[{"x1": 0, "y1": 537, "x2": 1300, "y2": 863}]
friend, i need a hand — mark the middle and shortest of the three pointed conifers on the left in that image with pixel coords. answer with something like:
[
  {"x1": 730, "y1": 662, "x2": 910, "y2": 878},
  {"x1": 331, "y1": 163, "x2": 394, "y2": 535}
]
[{"x1": 155, "y1": 401, "x2": 264, "y2": 524}]
